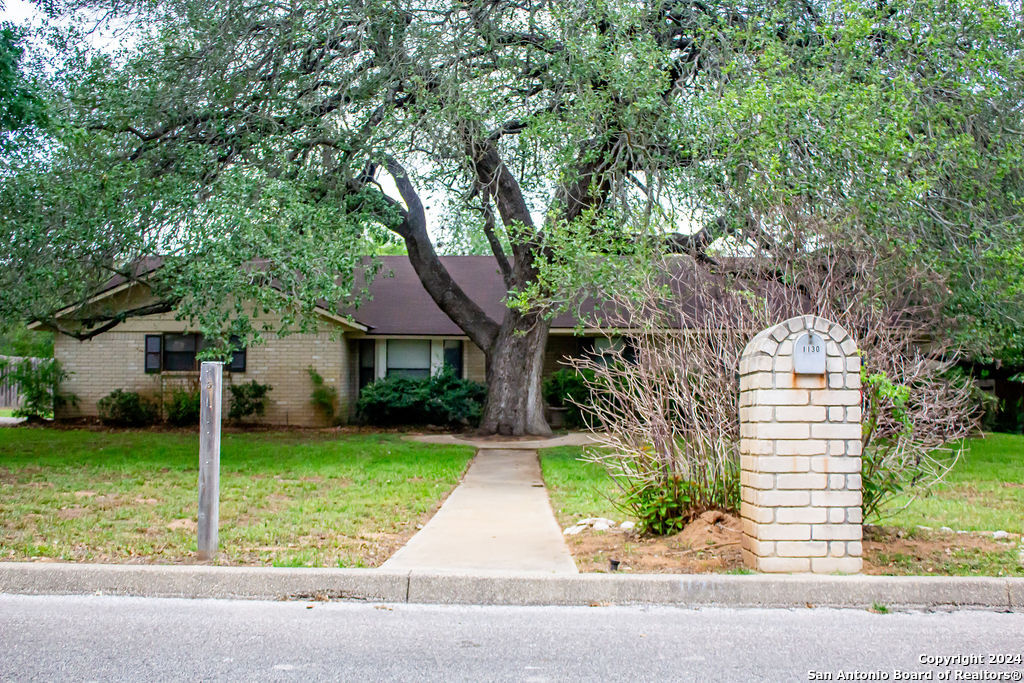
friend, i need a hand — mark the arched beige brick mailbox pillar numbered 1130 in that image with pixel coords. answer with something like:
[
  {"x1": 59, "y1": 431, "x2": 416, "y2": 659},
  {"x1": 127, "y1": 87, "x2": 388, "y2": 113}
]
[{"x1": 739, "y1": 315, "x2": 862, "y2": 573}]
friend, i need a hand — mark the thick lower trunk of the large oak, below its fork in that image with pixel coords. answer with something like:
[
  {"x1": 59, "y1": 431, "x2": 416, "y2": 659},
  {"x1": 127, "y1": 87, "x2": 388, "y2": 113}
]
[{"x1": 480, "y1": 310, "x2": 551, "y2": 436}]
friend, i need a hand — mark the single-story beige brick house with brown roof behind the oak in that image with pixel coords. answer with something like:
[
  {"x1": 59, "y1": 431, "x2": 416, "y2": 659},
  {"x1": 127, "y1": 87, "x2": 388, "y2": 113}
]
[{"x1": 37, "y1": 256, "x2": 607, "y2": 426}]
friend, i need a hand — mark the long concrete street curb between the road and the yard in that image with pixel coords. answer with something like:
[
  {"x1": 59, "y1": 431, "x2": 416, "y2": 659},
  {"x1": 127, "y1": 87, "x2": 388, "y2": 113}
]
[{"x1": 0, "y1": 562, "x2": 1024, "y2": 611}]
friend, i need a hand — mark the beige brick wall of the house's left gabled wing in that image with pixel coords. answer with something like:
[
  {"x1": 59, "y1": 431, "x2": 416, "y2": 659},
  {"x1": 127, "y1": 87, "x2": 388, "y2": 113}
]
[{"x1": 53, "y1": 314, "x2": 354, "y2": 426}]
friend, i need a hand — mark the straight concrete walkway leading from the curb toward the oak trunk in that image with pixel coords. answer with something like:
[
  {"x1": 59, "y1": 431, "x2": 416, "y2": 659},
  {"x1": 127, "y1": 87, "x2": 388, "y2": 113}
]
[{"x1": 381, "y1": 449, "x2": 577, "y2": 574}]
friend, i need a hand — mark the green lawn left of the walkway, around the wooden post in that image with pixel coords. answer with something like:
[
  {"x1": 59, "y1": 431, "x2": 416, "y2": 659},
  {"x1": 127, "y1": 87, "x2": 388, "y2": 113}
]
[{"x1": 0, "y1": 427, "x2": 473, "y2": 566}]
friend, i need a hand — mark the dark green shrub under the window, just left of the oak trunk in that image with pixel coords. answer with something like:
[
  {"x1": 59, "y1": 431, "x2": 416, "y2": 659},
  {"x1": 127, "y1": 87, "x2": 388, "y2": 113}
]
[{"x1": 356, "y1": 367, "x2": 487, "y2": 426}]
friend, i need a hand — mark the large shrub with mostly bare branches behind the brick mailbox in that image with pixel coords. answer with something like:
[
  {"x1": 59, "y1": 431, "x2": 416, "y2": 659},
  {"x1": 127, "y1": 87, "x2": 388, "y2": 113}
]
[{"x1": 570, "y1": 253, "x2": 977, "y2": 533}]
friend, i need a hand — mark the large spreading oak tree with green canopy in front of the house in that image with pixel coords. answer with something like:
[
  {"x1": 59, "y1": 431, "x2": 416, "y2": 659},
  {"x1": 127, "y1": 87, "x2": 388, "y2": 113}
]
[{"x1": 0, "y1": 0, "x2": 1024, "y2": 434}]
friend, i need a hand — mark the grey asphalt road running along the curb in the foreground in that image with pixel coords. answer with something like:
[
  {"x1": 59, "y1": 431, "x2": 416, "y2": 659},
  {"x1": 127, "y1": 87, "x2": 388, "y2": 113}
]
[{"x1": 0, "y1": 595, "x2": 1024, "y2": 681}]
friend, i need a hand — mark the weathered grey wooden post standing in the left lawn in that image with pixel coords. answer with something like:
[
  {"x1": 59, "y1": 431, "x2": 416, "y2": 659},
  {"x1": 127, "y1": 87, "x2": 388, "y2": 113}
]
[{"x1": 198, "y1": 360, "x2": 223, "y2": 560}]
